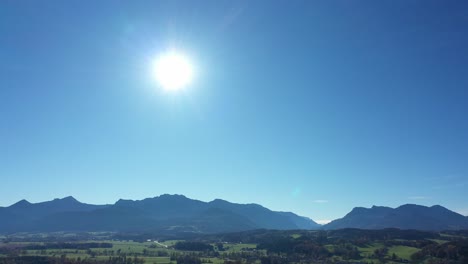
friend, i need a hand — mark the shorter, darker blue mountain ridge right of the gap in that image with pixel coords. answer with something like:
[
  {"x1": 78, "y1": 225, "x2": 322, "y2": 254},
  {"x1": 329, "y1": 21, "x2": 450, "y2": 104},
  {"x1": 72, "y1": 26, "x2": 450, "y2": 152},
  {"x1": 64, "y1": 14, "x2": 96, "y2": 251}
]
[{"x1": 323, "y1": 204, "x2": 468, "y2": 230}]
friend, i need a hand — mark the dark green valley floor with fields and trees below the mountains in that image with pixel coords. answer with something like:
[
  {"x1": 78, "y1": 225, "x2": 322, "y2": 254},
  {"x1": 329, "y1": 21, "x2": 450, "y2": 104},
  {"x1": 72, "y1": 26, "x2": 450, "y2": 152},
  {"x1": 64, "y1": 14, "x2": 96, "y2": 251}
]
[{"x1": 0, "y1": 229, "x2": 468, "y2": 264}]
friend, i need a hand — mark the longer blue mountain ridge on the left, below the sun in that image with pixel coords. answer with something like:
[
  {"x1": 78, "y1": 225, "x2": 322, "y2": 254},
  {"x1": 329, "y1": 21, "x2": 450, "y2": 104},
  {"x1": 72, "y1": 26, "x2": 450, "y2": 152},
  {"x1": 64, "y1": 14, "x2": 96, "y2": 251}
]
[{"x1": 0, "y1": 194, "x2": 320, "y2": 233}]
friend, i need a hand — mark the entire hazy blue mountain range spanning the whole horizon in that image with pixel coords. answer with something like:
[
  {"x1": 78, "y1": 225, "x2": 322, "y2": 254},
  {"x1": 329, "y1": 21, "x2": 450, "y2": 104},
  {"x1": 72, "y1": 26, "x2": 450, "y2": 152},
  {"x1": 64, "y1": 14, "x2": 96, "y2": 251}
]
[{"x1": 0, "y1": 194, "x2": 468, "y2": 233}]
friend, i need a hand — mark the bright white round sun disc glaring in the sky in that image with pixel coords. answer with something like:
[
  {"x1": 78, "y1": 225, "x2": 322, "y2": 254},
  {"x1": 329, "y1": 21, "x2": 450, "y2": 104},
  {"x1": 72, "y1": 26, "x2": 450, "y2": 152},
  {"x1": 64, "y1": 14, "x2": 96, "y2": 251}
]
[{"x1": 153, "y1": 51, "x2": 193, "y2": 91}]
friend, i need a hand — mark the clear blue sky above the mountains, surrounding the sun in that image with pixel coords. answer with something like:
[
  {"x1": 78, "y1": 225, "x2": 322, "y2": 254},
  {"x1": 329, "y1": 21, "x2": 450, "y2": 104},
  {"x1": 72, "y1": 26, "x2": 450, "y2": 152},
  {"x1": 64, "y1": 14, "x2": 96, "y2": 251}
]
[{"x1": 0, "y1": 0, "x2": 468, "y2": 221}]
